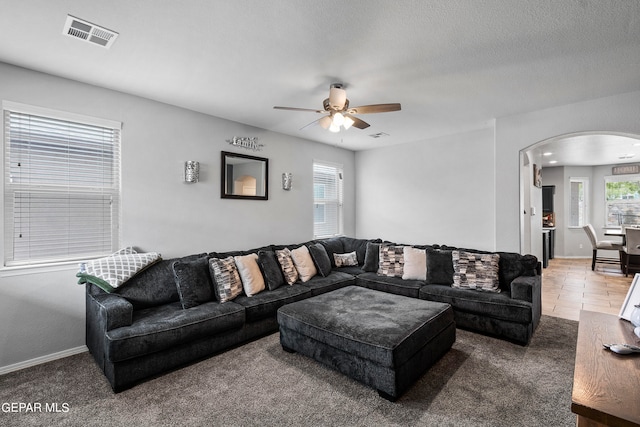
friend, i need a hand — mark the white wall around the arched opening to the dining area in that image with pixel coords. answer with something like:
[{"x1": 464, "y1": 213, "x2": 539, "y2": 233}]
[{"x1": 495, "y1": 91, "x2": 640, "y2": 257}]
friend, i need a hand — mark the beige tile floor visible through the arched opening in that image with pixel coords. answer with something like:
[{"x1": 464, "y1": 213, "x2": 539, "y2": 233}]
[{"x1": 542, "y1": 258, "x2": 633, "y2": 320}]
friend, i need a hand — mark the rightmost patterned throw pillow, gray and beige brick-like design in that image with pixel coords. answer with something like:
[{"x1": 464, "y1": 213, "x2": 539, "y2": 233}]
[{"x1": 451, "y1": 251, "x2": 500, "y2": 293}]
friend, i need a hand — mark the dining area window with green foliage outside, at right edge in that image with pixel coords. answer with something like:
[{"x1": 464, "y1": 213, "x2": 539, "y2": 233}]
[{"x1": 604, "y1": 175, "x2": 640, "y2": 227}]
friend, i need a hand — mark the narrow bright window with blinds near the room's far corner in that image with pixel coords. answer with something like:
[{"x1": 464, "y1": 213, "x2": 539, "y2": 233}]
[{"x1": 313, "y1": 161, "x2": 342, "y2": 238}]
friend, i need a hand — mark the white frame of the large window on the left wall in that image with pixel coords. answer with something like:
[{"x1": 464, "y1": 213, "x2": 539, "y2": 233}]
[{"x1": 0, "y1": 100, "x2": 122, "y2": 270}]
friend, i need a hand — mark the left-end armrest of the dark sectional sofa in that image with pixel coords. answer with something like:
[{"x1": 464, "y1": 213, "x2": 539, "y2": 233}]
[{"x1": 87, "y1": 293, "x2": 133, "y2": 332}]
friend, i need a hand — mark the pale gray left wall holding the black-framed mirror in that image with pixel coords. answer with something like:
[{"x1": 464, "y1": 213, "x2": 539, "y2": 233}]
[{"x1": 0, "y1": 63, "x2": 355, "y2": 372}]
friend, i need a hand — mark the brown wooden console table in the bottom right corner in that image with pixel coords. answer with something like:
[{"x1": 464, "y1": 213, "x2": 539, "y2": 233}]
[{"x1": 571, "y1": 310, "x2": 640, "y2": 427}]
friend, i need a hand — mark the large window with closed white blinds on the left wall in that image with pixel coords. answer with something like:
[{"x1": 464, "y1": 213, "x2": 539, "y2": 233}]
[{"x1": 3, "y1": 102, "x2": 121, "y2": 266}]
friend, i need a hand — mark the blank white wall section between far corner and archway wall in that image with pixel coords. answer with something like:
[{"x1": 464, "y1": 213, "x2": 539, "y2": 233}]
[{"x1": 356, "y1": 129, "x2": 495, "y2": 250}]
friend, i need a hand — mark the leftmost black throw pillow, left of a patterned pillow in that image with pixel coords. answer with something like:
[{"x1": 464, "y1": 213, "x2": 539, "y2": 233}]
[{"x1": 171, "y1": 257, "x2": 213, "y2": 310}]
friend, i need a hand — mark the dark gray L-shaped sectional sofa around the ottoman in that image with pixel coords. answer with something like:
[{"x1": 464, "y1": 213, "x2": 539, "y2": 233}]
[{"x1": 86, "y1": 237, "x2": 541, "y2": 392}]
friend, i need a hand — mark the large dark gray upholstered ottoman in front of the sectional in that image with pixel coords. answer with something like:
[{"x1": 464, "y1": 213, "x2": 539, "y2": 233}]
[{"x1": 278, "y1": 286, "x2": 456, "y2": 401}]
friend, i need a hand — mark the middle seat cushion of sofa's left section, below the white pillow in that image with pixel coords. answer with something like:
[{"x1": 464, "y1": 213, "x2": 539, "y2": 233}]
[{"x1": 233, "y1": 283, "x2": 311, "y2": 322}]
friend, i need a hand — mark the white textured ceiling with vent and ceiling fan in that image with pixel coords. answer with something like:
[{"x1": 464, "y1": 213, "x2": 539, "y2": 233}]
[{"x1": 0, "y1": 0, "x2": 640, "y2": 157}]
